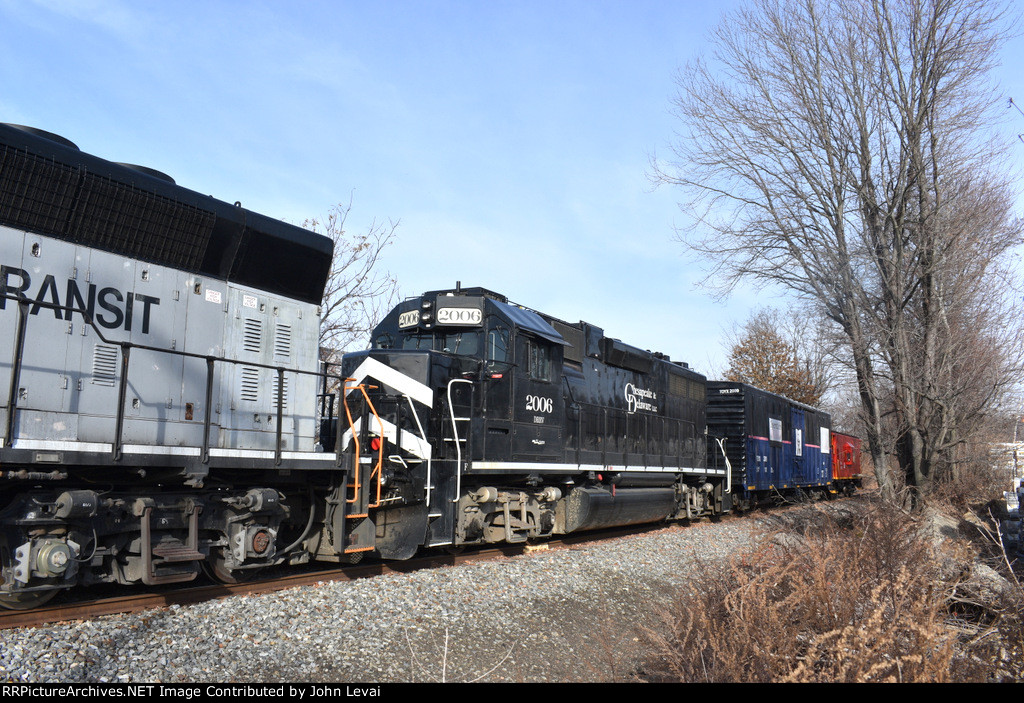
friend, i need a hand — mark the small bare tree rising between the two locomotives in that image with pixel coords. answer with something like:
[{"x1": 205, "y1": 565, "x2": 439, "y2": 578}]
[{"x1": 302, "y1": 200, "x2": 398, "y2": 363}]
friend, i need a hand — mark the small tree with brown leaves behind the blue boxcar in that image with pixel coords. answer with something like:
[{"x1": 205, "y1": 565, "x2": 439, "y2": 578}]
[{"x1": 725, "y1": 308, "x2": 828, "y2": 405}]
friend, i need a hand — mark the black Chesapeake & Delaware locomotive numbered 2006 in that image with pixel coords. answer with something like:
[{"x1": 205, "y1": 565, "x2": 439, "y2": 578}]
[{"x1": 342, "y1": 287, "x2": 726, "y2": 558}]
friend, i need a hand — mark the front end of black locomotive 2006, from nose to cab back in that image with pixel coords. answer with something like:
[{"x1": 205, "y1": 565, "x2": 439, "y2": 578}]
[{"x1": 342, "y1": 289, "x2": 573, "y2": 559}]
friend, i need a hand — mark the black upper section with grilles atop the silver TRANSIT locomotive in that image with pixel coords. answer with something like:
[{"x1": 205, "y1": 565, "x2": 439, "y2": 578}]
[{"x1": 0, "y1": 124, "x2": 334, "y2": 304}]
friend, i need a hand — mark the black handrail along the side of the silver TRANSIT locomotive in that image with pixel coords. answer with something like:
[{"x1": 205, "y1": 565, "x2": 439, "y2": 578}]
[{"x1": 2, "y1": 293, "x2": 344, "y2": 466}]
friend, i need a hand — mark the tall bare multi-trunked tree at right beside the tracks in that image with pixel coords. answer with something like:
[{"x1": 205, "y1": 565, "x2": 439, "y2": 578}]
[{"x1": 654, "y1": 0, "x2": 1021, "y2": 501}]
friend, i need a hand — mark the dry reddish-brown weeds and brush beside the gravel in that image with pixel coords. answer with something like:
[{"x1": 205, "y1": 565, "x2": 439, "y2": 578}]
[{"x1": 641, "y1": 502, "x2": 996, "y2": 683}]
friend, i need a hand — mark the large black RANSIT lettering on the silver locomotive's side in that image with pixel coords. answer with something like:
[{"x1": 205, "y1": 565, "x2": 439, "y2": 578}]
[{"x1": 0, "y1": 266, "x2": 160, "y2": 335}]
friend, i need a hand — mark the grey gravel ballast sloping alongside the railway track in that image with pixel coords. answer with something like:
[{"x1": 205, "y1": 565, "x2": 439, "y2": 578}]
[{"x1": 0, "y1": 518, "x2": 761, "y2": 684}]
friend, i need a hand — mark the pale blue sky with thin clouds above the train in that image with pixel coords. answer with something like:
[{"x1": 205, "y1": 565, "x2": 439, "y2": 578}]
[{"x1": 0, "y1": 0, "x2": 1024, "y2": 374}]
